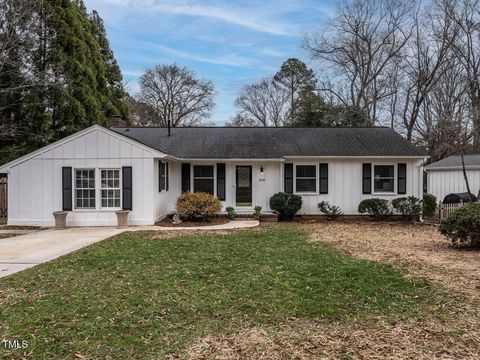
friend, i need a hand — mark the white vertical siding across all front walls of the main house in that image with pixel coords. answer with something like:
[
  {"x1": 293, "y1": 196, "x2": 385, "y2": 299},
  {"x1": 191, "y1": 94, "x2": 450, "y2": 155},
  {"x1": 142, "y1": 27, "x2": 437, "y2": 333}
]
[{"x1": 3, "y1": 127, "x2": 424, "y2": 226}]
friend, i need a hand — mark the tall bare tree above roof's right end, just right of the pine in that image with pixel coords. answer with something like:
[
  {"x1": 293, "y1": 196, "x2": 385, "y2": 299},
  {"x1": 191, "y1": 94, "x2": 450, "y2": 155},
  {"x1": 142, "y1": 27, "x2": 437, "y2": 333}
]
[{"x1": 303, "y1": 0, "x2": 415, "y2": 124}]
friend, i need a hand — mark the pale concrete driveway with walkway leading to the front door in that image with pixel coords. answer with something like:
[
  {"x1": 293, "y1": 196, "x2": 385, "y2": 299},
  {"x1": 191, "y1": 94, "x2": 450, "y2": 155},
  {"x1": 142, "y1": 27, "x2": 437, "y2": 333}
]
[{"x1": 0, "y1": 220, "x2": 259, "y2": 278}]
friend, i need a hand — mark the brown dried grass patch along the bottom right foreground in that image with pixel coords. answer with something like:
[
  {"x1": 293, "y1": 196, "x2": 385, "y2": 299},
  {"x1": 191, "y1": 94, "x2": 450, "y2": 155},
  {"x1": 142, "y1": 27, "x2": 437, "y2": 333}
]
[{"x1": 182, "y1": 308, "x2": 480, "y2": 360}]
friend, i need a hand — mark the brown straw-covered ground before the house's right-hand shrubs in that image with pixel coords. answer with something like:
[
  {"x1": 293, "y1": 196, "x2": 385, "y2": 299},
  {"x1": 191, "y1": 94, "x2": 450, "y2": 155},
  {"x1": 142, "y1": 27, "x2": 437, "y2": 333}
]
[{"x1": 306, "y1": 222, "x2": 480, "y2": 300}]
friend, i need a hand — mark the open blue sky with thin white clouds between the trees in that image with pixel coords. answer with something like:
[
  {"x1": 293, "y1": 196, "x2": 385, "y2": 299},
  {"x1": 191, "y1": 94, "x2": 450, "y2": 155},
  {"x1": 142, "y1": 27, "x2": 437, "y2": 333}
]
[{"x1": 85, "y1": 0, "x2": 335, "y2": 125}]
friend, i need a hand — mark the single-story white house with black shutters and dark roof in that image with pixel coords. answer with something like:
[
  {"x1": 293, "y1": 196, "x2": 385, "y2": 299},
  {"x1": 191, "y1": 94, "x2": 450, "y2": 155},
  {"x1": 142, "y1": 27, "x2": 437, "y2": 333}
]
[{"x1": 0, "y1": 125, "x2": 425, "y2": 226}]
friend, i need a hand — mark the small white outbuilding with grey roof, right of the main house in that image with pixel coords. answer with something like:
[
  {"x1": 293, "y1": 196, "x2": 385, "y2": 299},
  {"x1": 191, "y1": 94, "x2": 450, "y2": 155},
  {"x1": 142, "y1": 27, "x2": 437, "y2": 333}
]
[{"x1": 425, "y1": 155, "x2": 480, "y2": 201}]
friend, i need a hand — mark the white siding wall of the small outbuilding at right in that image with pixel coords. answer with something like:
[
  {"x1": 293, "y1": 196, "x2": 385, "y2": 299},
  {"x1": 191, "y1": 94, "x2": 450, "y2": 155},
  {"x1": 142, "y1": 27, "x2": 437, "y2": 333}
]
[{"x1": 427, "y1": 169, "x2": 480, "y2": 201}]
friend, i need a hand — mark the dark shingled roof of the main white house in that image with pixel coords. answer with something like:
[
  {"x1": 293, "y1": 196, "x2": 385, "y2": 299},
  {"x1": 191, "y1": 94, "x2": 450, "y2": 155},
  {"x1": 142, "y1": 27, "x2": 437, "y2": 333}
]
[{"x1": 111, "y1": 127, "x2": 425, "y2": 159}]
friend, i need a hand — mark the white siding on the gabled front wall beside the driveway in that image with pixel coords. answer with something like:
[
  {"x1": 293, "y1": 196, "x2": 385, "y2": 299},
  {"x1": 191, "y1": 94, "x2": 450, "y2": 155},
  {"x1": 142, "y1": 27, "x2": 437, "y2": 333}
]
[{"x1": 8, "y1": 128, "x2": 154, "y2": 226}]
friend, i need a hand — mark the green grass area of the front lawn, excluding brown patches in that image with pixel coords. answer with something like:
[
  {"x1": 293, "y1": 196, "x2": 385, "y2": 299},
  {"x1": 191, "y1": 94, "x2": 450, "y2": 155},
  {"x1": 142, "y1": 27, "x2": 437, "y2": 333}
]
[{"x1": 0, "y1": 224, "x2": 436, "y2": 359}]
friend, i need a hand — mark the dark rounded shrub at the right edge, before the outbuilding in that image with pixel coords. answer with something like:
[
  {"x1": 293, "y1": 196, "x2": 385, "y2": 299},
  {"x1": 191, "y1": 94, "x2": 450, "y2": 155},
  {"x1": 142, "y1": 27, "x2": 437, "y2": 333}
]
[{"x1": 438, "y1": 204, "x2": 480, "y2": 247}]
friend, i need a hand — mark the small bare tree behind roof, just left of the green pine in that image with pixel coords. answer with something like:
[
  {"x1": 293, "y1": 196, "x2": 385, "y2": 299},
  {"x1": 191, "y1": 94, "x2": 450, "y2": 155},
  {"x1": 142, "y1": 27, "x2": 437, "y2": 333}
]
[{"x1": 235, "y1": 78, "x2": 289, "y2": 127}]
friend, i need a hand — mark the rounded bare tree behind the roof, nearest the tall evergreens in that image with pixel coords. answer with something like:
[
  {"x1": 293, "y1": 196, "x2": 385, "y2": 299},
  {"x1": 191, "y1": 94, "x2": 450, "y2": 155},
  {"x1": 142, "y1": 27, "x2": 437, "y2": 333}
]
[{"x1": 139, "y1": 64, "x2": 215, "y2": 127}]
